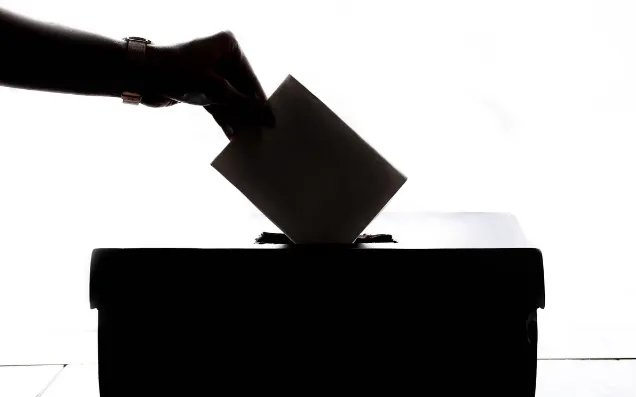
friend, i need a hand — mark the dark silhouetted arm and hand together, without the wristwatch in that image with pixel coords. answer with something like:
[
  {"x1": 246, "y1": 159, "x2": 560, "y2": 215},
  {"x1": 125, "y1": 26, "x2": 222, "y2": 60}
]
[{"x1": 0, "y1": 8, "x2": 274, "y2": 137}]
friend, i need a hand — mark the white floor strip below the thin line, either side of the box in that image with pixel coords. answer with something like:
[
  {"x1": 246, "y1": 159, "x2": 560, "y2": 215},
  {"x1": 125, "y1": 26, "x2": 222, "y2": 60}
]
[{"x1": 0, "y1": 360, "x2": 636, "y2": 397}]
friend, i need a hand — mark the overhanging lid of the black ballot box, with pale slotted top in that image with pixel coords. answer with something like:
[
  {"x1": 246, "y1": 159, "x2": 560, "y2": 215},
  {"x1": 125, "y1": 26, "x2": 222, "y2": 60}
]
[{"x1": 90, "y1": 213, "x2": 545, "y2": 310}]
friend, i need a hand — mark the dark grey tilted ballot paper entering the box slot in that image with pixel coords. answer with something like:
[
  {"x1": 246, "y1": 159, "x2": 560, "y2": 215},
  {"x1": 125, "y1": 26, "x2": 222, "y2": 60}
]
[{"x1": 212, "y1": 75, "x2": 407, "y2": 244}]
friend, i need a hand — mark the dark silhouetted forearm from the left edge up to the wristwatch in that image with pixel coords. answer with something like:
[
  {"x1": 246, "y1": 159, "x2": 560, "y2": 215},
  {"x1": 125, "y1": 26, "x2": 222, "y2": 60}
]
[{"x1": 0, "y1": 9, "x2": 158, "y2": 97}]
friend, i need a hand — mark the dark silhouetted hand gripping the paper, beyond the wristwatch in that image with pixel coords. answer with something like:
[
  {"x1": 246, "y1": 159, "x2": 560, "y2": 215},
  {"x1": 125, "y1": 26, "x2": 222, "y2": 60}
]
[{"x1": 142, "y1": 32, "x2": 275, "y2": 139}]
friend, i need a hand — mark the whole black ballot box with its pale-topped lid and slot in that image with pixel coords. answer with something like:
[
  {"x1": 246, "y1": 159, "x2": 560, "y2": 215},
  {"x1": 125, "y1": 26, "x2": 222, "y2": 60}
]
[{"x1": 90, "y1": 213, "x2": 545, "y2": 397}]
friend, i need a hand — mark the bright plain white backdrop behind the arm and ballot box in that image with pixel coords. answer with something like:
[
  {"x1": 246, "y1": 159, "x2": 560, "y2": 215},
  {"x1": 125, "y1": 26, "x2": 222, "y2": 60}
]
[{"x1": 0, "y1": 0, "x2": 636, "y2": 361}]
